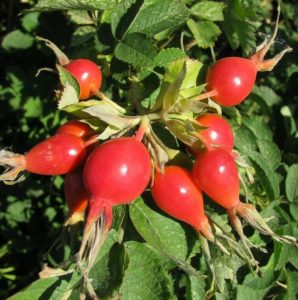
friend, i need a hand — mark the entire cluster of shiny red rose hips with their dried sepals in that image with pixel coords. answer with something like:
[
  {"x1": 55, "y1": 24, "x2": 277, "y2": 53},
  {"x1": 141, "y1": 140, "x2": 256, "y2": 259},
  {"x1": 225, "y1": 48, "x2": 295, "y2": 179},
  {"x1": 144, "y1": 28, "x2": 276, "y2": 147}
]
[{"x1": 0, "y1": 13, "x2": 297, "y2": 288}]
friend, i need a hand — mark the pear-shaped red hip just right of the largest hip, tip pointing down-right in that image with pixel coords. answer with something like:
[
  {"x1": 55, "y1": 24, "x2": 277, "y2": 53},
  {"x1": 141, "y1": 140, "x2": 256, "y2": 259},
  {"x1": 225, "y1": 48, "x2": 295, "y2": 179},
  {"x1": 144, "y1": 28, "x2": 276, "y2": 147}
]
[{"x1": 151, "y1": 166, "x2": 249, "y2": 280}]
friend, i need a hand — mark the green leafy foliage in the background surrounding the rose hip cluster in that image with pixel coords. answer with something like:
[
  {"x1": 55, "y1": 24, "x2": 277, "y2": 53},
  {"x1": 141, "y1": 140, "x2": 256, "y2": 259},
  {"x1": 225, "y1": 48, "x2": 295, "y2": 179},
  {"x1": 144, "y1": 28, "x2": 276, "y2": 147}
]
[{"x1": 0, "y1": 0, "x2": 298, "y2": 300}]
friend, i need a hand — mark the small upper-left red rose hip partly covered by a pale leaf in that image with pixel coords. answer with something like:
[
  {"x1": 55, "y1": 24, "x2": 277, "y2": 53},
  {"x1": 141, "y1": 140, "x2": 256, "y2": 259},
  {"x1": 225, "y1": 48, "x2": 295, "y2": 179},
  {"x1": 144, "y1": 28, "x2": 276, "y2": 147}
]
[{"x1": 64, "y1": 59, "x2": 102, "y2": 100}]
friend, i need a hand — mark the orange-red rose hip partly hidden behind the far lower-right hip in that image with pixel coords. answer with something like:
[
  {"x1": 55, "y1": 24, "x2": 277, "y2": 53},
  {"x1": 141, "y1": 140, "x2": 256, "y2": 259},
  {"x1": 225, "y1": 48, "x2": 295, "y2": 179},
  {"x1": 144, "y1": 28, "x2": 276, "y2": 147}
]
[{"x1": 189, "y1": 114, "x2": 234, "y2": 156}]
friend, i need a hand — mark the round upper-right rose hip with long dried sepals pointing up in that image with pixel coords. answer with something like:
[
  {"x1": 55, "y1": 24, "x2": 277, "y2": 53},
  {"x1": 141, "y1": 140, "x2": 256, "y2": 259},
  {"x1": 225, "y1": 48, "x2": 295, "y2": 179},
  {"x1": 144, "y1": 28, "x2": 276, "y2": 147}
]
[{"x1": 197, "y1": 7, "x2": 292, "y2": 106}]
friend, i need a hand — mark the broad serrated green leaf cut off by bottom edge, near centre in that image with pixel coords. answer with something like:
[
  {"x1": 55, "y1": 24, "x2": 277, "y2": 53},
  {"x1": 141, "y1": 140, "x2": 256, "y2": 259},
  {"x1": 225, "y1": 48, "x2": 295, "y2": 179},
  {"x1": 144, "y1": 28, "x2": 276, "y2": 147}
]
[{"x1": 120, "y1": 241, "x2": 174, "y2": 300}]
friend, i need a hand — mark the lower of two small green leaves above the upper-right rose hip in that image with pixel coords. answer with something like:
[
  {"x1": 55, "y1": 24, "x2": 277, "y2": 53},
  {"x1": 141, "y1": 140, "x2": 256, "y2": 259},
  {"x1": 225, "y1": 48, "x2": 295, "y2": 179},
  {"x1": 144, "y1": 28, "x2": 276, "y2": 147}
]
[{"x1": 187, "y1": 19, "x2": 221, "y2": 49}]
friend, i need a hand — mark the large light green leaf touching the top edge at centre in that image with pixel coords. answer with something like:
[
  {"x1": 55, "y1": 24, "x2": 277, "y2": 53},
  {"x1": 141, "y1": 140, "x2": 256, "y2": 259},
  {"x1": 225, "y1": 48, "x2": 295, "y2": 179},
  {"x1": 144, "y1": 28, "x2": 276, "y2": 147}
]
[{"x1": 127, "y1": 0, "x2": 189, "y2": 36}]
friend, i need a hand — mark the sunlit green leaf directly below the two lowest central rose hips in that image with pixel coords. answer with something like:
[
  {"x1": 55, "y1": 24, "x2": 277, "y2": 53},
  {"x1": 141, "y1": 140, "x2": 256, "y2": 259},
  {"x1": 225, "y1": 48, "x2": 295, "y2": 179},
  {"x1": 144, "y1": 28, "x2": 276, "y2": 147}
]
[{"x1": 129, "y1": 198, "x2": 195, "y2": 260}]
